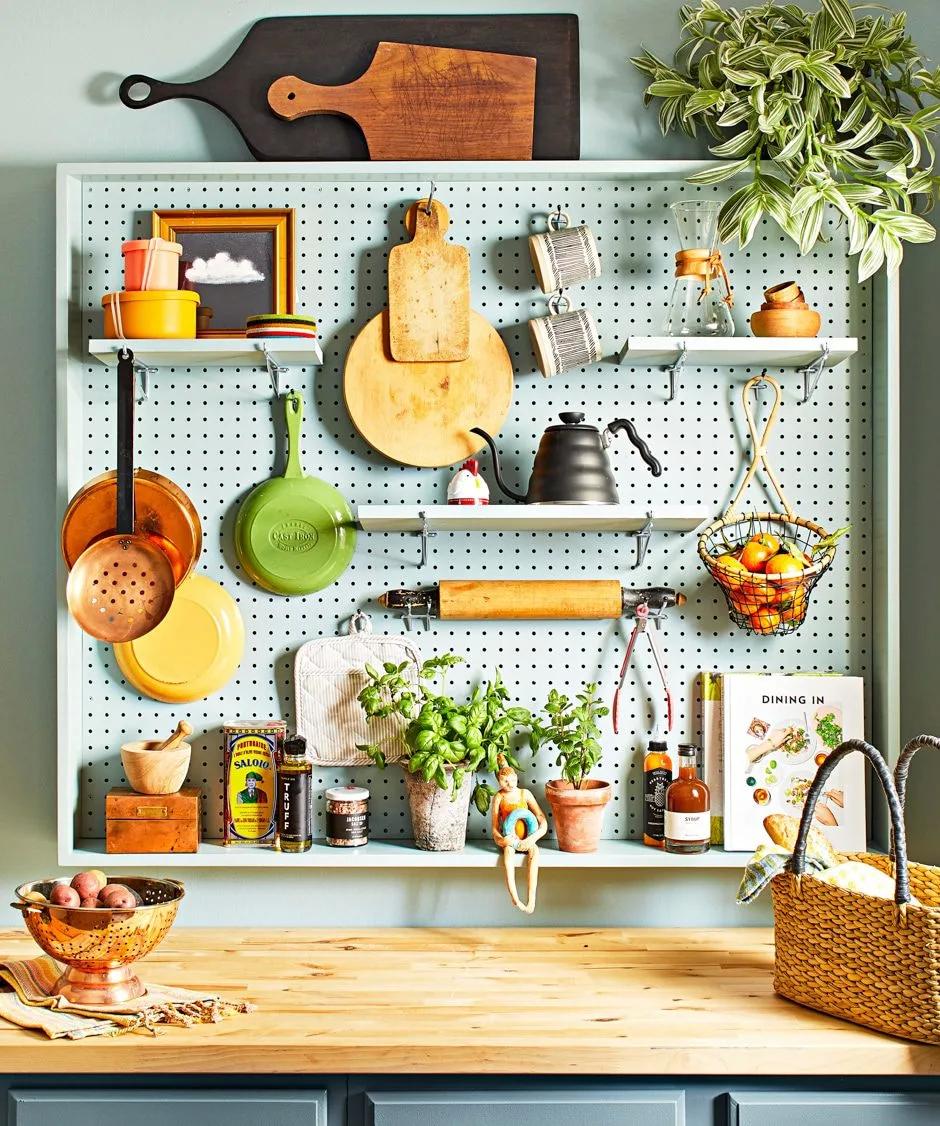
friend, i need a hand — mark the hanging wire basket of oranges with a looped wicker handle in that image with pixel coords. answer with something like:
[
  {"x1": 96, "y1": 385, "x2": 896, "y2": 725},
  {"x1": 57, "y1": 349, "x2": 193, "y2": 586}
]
[{"x1": 698, "y1": 372, "x2": 845, "y2": 634}]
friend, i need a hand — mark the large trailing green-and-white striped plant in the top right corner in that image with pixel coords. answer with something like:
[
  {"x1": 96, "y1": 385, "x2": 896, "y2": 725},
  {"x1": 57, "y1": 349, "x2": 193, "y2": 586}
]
[{"x1": 633, "y1": 0, "x2": 940, "y2": 280}]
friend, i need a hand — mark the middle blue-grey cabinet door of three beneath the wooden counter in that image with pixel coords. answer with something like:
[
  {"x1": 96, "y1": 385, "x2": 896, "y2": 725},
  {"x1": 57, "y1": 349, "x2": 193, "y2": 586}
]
[{"x1": 366, "y1": 1091, "x2": 686, "y2": 1126}]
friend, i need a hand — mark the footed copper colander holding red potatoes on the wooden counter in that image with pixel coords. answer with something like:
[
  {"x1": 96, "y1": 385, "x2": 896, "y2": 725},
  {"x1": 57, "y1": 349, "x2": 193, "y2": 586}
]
[{"x1": 11, "y1": 876, "x2": 186, "y2": 1004}]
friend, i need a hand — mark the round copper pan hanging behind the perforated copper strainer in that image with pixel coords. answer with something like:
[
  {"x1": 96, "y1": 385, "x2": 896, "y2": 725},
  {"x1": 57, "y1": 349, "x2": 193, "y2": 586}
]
[{"x1": 60, "y1": 470, "x2": 203, "y2": 586}]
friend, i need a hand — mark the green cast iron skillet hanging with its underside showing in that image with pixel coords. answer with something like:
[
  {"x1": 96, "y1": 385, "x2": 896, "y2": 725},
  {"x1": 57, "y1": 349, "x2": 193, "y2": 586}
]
[{"x1": 235, "y1": 391, "x2": 356, "y2": 595}]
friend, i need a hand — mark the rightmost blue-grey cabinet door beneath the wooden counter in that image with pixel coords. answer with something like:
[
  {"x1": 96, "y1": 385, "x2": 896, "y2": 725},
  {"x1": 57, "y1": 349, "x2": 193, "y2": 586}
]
[{"x1": 727, "y1": 1091, "x2": 940, "y2": 1126}]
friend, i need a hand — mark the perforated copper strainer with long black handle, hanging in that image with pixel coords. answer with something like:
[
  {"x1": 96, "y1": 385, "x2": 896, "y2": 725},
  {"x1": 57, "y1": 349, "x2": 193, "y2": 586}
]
[{"x1": 65, "y1": 348, "x2": 176, "y2": 642}]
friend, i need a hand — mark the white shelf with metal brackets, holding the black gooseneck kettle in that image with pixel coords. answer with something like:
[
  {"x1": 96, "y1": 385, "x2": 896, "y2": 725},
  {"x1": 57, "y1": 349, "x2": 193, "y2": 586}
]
[{"x1": 357, "y1": 504, "x2": 709, "y2": 566}]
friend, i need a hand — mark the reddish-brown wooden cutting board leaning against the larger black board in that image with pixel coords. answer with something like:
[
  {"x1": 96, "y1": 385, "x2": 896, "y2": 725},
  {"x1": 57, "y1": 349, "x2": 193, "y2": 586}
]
[{"x1": 268, "y1": 43, "x2": 536, "y2": 160}]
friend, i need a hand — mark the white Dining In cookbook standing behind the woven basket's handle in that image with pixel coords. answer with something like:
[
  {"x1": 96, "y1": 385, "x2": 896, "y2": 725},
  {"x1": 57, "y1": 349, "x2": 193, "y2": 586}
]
[{"x1": 720, "y1": 672, "x2": 867, "y2": 852}]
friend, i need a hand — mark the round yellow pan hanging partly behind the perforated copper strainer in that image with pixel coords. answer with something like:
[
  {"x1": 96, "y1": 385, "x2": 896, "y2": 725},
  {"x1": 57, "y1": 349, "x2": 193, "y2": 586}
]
[{"x1": 114, "y1": 573, "x2": 244, "y2": 704}]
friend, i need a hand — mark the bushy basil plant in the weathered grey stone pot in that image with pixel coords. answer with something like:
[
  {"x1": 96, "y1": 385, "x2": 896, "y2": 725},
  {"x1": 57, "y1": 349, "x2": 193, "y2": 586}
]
[{"x1": 358, "y1": 653, "x2": 531, "y2": 852}]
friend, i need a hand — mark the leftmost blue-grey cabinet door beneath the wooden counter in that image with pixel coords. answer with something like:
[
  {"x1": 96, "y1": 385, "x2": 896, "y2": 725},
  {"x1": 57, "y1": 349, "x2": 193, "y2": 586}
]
[{"x1": 10, "y1": 1088, "x2": 326, "y2": 1126}]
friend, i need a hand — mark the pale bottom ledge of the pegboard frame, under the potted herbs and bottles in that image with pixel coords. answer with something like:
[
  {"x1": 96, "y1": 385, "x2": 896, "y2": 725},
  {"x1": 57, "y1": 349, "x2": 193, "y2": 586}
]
[{"x1": 68, "y1": 838, "x2": 750, "y2": 874}]
